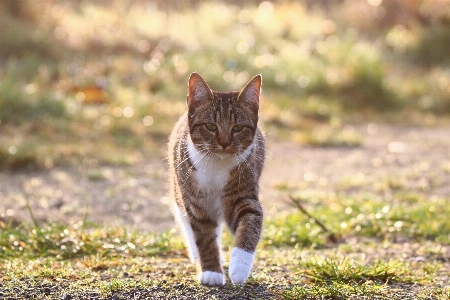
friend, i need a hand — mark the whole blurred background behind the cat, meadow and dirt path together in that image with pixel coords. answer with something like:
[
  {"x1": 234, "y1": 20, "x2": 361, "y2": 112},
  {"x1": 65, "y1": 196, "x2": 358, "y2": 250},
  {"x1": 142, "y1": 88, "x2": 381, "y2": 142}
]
[{"x1": 0, "y1": 0, "x2": 450, "y2": 231}]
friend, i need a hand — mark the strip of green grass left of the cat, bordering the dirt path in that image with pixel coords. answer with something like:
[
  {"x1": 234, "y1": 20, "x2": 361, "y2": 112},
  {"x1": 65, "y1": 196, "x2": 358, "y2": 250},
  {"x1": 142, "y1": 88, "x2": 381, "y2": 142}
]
[{"x1": 0, "y1": 222, "x2": 180, "y2": 260}]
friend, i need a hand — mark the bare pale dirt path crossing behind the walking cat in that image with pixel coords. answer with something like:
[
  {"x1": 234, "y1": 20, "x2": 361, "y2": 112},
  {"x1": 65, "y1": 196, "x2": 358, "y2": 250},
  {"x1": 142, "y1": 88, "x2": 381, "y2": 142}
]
[{"x1": 0, "y1": 124, "x2": 450, "y2": 231}]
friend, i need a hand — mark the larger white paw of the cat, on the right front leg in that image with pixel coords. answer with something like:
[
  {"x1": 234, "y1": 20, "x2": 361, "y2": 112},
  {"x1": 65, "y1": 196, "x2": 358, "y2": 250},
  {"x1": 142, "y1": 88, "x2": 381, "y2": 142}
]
[{"x1": 228, "y1": 247, "x2": 255, "y2": 284}]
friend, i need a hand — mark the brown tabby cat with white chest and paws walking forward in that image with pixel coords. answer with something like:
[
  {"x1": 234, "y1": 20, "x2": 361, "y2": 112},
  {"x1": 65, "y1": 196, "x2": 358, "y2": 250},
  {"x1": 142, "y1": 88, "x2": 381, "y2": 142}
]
[{"x1": 168, "y1": 73, "x2": 265, "y2": 286}]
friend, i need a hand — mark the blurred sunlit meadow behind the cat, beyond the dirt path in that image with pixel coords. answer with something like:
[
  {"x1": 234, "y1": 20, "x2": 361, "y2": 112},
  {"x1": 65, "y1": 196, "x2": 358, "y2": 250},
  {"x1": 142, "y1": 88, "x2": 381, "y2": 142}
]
[{"x1": 0, "y1": 0, "x2": 450, "y2": 170}]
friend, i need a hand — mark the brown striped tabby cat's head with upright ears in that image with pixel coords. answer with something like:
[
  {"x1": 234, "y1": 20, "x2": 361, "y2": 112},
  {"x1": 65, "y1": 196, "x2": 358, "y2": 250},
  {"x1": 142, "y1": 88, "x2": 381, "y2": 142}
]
[{"x1": 187, "y1": 73, "x2": 261, "y2": 154}]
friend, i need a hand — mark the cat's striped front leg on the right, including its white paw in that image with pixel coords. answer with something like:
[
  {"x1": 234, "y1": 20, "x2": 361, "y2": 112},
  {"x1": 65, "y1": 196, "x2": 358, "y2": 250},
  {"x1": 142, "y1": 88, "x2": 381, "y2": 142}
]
[{"x1": 227, "y1": 198, "x2": 263, "y2": 284}]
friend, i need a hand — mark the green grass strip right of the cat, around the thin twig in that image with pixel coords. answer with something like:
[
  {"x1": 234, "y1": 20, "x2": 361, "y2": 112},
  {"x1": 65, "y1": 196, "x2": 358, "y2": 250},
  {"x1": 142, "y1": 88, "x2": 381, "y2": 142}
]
[{"x1": 264, "y1": 192, "x2": 450, "y2": 247}]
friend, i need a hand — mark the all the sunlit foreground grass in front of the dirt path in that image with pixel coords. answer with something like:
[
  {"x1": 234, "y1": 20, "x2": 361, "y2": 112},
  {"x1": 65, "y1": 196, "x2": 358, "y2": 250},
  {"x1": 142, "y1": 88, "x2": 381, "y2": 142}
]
[{"x1": 0, "y1": 199, "x2": 450, "y2": 299}]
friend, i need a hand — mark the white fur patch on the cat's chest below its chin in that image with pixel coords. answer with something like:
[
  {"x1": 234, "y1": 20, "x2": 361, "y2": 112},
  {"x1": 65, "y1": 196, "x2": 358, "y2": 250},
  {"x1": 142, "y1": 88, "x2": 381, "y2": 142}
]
[{"x1": 188, "y1": 137, "x2": 253, "y2": 215}]
